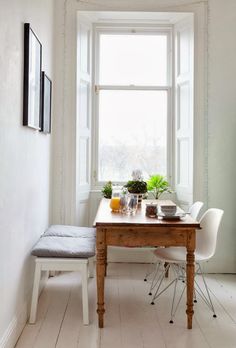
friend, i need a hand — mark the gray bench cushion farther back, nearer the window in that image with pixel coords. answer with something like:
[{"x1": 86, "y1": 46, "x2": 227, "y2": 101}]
[{"x1": 43, "y1": 225, "x2": 96, "y2": 238}]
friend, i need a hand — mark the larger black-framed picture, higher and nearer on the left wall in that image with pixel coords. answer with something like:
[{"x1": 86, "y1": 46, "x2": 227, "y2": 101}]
[{"x1": 23, "y1": 23, "x2": 42, "y2": 130}]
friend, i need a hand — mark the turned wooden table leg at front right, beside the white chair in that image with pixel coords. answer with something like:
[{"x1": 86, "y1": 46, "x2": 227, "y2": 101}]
[{"x1": 186, "y1": 231, "x2": 195, "y2": 329}]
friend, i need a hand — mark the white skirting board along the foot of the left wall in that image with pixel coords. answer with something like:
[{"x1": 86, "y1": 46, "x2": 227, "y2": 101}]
[{"x1": 0, "y1": 272, "x2": 48, "y2": 348}]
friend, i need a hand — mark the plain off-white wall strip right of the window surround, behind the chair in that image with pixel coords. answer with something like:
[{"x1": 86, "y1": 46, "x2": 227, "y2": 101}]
[{"x1": 208, "y1": 0, "x2": 236, "y2": 272}]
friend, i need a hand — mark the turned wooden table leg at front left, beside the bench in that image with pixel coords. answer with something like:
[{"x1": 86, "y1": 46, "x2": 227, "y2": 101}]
[{"x1": 97, "y1": 228, "x2": 106, "y2": 328}]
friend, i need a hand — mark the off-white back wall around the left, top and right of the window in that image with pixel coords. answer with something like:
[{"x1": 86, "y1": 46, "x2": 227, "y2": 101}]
[{"x1": 53, "y1": 0, "x2": 236, "y2": 272}]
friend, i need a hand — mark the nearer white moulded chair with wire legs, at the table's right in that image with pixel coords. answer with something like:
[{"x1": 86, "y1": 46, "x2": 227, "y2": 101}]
[{"x1": 148, "y1": 208, "x2": 224, "y2": 323}]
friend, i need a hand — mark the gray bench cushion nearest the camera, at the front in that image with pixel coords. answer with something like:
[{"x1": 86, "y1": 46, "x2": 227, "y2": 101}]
[{"x1": 31, "y1": 236, "x2": 95, "y2": 258}]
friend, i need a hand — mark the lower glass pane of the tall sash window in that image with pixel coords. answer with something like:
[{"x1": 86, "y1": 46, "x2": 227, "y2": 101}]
[{"x1": 98, "y1": 90, "x2": 167, "y2": 181}]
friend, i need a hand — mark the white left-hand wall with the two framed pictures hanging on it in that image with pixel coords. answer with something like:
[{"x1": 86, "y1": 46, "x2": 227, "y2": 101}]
[{"x1": 0, "y1": 0, "x2": 54, "y2": 347}]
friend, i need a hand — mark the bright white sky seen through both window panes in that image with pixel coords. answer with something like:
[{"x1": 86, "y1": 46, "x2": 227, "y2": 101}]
[{"x1": 98, "y1": 34, "x2": 167, "y2": 180}]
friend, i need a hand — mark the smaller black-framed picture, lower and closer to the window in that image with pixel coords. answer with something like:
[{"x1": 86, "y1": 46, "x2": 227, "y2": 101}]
[{"x1": 41, "y1": 71, "x2": 52, "y2": 133}]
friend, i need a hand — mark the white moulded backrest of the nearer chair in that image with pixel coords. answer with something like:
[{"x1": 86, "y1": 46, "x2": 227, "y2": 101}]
[{"x1": 196, "y1": 208, "x2": 224, "y2": 259}]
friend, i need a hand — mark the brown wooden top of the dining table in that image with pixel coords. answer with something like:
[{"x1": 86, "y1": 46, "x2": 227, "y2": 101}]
[{"x1": 93, "y1": 198, "x2": 200, "y2": 229}]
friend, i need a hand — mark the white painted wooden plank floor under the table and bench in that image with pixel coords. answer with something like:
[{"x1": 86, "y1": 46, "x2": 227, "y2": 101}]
[{"x1": 16, "y1": 264, "x2": 236, "y2": 348}]
